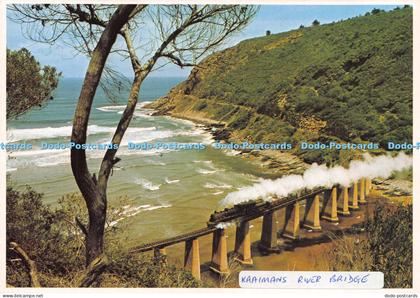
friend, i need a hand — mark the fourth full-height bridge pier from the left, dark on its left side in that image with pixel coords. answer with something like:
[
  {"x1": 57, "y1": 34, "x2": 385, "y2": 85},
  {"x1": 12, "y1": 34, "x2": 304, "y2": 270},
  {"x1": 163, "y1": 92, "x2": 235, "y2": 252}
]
[{"x1": 258, "y1": 211, "x2": 281, "y2": 253}]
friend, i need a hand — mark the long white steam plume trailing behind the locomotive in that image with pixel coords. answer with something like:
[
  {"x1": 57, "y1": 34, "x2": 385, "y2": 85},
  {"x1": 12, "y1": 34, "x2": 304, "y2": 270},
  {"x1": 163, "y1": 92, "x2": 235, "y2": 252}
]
[{"x1": 220, "y1": 152, "x2": 413, "y2": 206}]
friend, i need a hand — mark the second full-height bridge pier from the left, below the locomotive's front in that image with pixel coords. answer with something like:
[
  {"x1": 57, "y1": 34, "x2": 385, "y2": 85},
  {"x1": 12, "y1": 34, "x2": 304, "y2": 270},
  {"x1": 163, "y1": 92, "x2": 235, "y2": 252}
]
[{"x1": 210, "y1": 229, "x2": 229, "y2": 275}]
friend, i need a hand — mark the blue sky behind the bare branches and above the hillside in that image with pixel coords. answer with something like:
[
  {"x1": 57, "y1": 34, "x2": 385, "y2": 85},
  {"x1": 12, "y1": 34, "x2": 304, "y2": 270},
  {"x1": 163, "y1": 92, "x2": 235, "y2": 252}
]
[{"x1": 7, "y1": 5, "x2": 398, "y2": 78}]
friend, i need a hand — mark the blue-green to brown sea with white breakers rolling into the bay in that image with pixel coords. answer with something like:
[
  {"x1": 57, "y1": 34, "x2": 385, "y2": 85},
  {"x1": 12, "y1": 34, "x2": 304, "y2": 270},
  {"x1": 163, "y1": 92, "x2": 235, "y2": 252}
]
[{"x1": 7, "y1": 77, "x2": 258, "y2": 246}]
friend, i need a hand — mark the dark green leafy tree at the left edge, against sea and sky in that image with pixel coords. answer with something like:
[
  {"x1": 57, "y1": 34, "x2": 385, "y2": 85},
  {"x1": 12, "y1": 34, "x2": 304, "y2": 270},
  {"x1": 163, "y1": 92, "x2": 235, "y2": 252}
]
[{"x1": 6, "y1": 48, "x2": 61, "y2": 119}]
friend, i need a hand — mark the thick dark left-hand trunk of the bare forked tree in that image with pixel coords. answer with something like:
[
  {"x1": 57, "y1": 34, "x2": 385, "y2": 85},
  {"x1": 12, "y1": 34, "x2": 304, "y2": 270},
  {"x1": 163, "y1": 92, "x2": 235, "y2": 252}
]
[{"x1": 71, "y1": 5, "x2": 136, "y2": 266}]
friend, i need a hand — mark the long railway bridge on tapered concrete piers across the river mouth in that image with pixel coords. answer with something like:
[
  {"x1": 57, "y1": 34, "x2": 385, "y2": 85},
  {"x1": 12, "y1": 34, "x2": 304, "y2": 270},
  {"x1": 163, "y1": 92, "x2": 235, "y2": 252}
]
[{"x1": 132, "y1": 178, "x2": 372, "y2": 279}]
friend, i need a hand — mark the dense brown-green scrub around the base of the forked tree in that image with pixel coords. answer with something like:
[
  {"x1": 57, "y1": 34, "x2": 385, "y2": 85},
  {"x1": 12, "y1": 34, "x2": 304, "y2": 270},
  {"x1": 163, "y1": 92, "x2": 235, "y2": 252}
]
[{"x1": 6, "y1": 186, "x2": 201, "y2": 287}]
